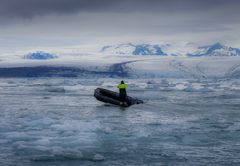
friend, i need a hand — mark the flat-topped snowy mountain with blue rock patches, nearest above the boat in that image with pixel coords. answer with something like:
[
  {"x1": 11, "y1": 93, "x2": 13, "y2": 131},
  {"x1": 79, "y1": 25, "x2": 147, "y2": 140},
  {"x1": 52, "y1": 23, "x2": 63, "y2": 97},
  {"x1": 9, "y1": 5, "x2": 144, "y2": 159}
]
[{"x1": 100, "y1": 43, "x2": 167, "y2": 56}]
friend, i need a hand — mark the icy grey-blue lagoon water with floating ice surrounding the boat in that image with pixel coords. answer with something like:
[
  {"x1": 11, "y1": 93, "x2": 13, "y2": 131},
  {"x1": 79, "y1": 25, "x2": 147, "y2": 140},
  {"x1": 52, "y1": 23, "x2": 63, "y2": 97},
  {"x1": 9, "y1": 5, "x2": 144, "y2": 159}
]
[{"x1": 0, "y1": 78, "x2": 240, "y2": 166}]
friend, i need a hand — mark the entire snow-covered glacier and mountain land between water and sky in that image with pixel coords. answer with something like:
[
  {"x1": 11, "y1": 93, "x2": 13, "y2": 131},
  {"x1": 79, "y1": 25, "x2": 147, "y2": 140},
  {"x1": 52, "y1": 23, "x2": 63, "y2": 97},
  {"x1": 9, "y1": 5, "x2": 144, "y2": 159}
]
[{"x1": 0, "y1": 43, "x2": 240, "y2": 80}]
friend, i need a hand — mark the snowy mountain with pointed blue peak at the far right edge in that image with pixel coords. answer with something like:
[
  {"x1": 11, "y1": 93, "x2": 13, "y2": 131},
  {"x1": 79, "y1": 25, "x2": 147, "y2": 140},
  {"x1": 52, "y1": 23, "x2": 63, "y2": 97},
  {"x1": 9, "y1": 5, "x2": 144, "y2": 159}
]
[{"x1": 188, "y1": 43, "x2": 240, "y2": 56}]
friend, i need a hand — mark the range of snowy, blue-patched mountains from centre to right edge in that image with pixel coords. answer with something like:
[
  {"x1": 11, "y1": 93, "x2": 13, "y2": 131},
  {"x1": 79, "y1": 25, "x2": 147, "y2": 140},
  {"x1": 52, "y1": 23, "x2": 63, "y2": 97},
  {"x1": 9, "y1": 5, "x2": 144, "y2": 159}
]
[{"x1": 100, "y1": 43, "x2": 240, "y2": 56}]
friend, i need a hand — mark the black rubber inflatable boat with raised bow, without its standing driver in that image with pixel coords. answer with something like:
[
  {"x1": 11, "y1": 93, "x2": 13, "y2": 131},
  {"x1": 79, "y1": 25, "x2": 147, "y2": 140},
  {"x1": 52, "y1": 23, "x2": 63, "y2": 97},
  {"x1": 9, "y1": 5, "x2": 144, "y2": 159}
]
[{"x1": 94, "y1": 88, "x2": 143, "y2": 107}]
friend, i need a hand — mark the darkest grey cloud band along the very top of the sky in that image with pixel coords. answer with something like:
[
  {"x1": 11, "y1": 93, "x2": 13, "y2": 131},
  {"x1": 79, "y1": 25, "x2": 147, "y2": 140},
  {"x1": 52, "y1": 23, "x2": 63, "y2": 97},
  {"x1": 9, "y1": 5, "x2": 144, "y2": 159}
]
[{"x1": 0, "y1": 0, "x2": 240, "y2": 18}]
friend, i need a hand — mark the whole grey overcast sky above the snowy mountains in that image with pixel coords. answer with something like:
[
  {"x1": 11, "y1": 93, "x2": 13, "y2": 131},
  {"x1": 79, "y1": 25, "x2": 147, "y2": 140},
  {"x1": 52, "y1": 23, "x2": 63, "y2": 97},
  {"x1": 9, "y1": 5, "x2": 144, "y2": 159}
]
[{"x1": 0, "y1": 0, "x2": 240, "y2": 48}]
